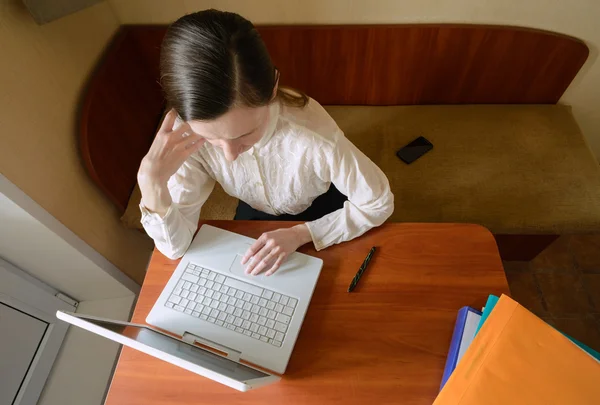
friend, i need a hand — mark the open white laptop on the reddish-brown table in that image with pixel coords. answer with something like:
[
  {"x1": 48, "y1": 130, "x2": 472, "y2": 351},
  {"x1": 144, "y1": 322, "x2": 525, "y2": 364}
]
[{"x1": 61, "y1": 225, "x2": 323, "y2": 389}]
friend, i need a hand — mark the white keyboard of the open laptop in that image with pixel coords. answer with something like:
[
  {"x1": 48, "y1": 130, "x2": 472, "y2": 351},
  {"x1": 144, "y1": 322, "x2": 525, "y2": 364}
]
[{"x1": 165, "y1": 263, "x2": 298, "y2": 347}]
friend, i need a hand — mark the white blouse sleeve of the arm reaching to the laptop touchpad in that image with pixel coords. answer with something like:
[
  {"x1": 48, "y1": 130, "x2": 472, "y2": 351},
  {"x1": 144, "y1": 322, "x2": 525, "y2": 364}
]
[{"x1": 306, "y1": 131, "x2": 394, "y2": 250}]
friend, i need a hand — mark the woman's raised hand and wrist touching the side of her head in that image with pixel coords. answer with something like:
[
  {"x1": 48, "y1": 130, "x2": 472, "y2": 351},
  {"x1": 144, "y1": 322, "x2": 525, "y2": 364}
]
[{"x1": 138, "y1": 110, "x2": 205, "y2": 216}]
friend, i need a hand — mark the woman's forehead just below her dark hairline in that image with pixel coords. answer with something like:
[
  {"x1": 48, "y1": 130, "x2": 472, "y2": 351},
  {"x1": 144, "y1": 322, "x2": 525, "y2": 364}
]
[{"x1": 188, "y1": 106, "x2": 269, "y2": 139}]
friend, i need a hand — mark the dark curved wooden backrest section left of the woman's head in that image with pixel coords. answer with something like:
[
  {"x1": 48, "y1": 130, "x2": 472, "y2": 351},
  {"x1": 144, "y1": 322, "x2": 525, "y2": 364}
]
[{"x1": 79, "y1": 27, "x2": 165, "y2": 213}]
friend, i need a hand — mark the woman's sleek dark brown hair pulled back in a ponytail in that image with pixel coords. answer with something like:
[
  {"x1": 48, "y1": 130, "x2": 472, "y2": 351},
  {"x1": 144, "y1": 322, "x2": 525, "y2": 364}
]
[{"x1": 160, "y1": 10, "x2": 308, "y2": 121}]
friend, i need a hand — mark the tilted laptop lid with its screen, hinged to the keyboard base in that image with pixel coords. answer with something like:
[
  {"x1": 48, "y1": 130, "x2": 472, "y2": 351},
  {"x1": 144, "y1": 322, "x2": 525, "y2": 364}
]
[{"x1": 56, "y1": 311, "x2": 279, "y2": 391}]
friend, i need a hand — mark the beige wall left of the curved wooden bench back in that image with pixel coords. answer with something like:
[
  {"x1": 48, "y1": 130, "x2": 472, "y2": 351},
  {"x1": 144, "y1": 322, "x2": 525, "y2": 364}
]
[{"x1": 0, "y1": 0, "x2": 151, "y2": 282}]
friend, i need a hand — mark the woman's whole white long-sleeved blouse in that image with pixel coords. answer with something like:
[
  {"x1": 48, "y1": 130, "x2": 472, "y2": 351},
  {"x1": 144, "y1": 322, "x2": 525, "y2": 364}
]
[{"x1": 140, "y1": 99, "x2": 394, "y2": 259}]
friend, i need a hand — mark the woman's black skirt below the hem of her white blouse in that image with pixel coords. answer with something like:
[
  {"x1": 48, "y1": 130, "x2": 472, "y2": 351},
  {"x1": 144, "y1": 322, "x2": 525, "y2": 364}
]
[{"x1": 233, "y1": 184, "x2": 348, "y2": 222}]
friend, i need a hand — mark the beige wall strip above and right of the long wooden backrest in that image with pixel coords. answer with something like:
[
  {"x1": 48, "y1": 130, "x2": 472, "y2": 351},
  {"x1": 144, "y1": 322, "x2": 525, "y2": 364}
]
[{"x1": 108, "y1": 0, "x2": 600, "y2": 158}]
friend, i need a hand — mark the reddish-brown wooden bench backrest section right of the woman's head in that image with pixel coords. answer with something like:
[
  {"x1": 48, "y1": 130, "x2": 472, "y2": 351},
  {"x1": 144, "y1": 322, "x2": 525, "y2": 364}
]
[{"x1": 259, "y1": 24, "x2": 589, "y2": 105}]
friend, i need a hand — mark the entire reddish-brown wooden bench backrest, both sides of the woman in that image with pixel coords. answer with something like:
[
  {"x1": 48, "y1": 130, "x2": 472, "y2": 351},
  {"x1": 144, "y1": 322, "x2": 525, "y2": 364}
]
[{"x1": 79, "y1": 24, "x2": 589, "y2": 212}]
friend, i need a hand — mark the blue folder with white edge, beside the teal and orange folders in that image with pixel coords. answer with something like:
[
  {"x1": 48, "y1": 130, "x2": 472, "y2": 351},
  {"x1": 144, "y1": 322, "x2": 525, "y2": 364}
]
[{"x1": 440, "y1": 307, "x2": 481, "y2": 390}]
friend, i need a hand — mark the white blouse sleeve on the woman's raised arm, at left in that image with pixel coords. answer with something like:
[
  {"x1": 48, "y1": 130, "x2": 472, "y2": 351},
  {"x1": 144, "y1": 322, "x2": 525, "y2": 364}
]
[{"x1": 140, "y1": 156, "x2": 215, "y2": 259}]
